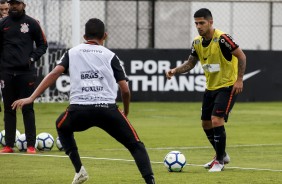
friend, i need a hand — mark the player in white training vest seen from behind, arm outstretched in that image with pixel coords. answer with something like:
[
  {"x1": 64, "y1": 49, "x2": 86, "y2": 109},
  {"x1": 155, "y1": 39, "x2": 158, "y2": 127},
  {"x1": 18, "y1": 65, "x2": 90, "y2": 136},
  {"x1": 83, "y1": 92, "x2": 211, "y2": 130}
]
[{"x1": 12, "y1": 18, "x2": 155, "y2": 184}]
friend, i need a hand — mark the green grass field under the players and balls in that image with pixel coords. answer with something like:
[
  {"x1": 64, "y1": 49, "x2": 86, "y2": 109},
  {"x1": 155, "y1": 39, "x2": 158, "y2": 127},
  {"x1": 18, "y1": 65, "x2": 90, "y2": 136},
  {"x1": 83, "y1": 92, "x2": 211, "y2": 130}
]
[{"x1": 0, "y1": 102, "x2": 282, "y2": 184}]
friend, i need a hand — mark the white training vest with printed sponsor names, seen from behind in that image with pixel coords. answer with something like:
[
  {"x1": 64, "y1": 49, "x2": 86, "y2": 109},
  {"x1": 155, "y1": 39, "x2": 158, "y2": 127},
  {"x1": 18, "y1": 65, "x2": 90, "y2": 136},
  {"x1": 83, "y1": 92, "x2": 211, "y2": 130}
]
[{"x1": 69, "y1": 44, "x2": 118, "y2": 105}]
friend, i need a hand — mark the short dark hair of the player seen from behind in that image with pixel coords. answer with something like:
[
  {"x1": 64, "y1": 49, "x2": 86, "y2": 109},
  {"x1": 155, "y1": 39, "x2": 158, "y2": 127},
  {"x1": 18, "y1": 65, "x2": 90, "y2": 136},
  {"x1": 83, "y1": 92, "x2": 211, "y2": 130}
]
[{"x1": 85, "y1": 18, "x2": 105, "y2": 39}]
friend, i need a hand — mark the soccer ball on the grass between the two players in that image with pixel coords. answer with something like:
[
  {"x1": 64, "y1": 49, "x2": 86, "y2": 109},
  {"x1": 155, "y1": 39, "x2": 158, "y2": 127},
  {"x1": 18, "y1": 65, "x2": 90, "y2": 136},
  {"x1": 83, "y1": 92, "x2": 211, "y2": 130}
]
[{"x1": 164, "y1": 151, "x2": 186, "y2": 172}]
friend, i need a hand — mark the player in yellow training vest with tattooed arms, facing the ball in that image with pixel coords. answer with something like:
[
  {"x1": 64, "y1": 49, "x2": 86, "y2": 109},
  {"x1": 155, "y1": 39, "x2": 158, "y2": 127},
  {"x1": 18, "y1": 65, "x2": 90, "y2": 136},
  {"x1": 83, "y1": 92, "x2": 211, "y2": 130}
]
[{"x1": 166, "y1": 8, "x2": 246, "y2": 172}]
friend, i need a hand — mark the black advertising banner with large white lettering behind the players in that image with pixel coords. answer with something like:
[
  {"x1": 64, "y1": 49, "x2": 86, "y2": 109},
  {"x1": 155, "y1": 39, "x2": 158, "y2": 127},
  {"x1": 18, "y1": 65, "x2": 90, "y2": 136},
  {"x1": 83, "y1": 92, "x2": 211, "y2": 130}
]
[{"x1": 46, "y1": 49, "x2": 282, "y2": 102}]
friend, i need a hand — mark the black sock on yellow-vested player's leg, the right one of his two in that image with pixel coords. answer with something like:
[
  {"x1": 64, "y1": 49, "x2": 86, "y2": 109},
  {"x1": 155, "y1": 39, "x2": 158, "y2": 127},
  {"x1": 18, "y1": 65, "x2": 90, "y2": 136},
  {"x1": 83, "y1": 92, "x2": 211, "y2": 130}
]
[{"x1": 214, "y1": 126, "x2": 226, "y2": 163}]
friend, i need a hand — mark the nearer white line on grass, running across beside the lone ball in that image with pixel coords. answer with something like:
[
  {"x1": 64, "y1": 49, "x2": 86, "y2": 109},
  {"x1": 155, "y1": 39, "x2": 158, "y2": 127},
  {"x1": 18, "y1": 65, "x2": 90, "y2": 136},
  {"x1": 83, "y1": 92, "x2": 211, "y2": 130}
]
[{"x1": 0, "y1": 153, "x2": 282, "y2": 172}]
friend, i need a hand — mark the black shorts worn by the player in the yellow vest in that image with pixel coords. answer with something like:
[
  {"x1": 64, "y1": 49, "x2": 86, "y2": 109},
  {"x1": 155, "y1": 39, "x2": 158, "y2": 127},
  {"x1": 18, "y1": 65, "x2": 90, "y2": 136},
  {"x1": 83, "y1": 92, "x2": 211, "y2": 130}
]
[{"x1": 201, "y1": 86, "x2": 237, "y2": 122}]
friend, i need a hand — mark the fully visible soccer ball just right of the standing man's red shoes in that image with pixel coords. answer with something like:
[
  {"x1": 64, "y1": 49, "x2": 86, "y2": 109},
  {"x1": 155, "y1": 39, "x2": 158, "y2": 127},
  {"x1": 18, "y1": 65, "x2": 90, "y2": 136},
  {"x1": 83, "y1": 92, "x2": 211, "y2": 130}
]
[{"x1": 36, "y1": 132, "x2": 54, "y2": 151}]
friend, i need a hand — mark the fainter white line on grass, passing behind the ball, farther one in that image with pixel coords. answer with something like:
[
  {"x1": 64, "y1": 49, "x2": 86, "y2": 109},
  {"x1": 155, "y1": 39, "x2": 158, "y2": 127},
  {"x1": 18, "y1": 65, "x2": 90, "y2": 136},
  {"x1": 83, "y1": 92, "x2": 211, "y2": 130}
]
[{"x1": 102, "y1": 144, "x2": 282, "y2": 151}]
